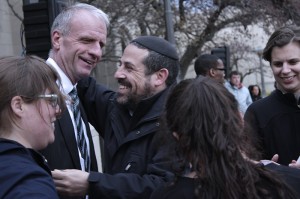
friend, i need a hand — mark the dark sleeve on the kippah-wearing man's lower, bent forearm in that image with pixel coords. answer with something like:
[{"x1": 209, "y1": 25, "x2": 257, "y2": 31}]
[{"x1": 88, "y1": 145, "x2": 174, "y2": 199}]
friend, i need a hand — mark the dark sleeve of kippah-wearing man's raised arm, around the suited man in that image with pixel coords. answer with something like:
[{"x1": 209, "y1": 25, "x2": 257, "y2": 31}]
[{"x1": 77, "y1": 77, "x2": 114, "y2": 132}]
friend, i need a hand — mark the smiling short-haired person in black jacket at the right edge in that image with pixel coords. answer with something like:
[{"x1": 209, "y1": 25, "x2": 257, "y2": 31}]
[{"x1": 245, "y1": 26, "x2": 300, "y2": 168}]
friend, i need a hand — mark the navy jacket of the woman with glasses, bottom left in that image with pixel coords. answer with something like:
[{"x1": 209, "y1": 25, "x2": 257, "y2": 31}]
[{"x1": 0, "y1": 138, "x2": 58, "y2": 199}]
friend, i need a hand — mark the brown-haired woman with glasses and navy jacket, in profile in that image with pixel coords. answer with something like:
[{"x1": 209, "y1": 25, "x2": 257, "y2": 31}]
[{"x1": 0, "y1": 56, "x2": 65, "y2": 199}]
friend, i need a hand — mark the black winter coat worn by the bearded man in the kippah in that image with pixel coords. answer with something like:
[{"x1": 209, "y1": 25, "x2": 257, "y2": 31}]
[{"x1": 77, "y1": 78, "x2": 173, "y2": 199}]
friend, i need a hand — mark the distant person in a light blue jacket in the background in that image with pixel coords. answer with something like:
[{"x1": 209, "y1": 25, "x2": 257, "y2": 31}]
[{"x1": 225, "y1": 71, "x2": 252, "y2": 116}]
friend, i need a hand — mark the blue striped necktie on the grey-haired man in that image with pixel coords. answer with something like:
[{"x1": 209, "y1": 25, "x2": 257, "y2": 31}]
[{"x1": 69, "y1": 87, "x2": 90, "y2": 172}]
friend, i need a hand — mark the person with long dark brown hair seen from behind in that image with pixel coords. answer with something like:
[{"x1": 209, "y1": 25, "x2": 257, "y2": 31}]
[{"x1": 151, "y1": 77, "x2": 300, "y2": 199}]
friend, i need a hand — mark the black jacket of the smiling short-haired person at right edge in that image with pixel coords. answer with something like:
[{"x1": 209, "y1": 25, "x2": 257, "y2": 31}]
[{"x1": 244, "y1": 90, "x2": 300, "y2": 165}]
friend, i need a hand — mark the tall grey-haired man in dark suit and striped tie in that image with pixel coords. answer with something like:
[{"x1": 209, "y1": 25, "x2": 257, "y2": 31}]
[{"x1": 41, "y1": 3, "x2": 109, "y2": 198}]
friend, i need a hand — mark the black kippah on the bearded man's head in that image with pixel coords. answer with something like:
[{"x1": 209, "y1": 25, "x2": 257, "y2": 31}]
[{"x1": 131, "y1": 36, "x2": 179, "y2": 60}]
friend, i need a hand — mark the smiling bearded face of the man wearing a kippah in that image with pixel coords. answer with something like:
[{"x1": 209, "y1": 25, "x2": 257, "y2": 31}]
[{"x1": 115, "y1": 44, "x2": 155, "y2": 104}]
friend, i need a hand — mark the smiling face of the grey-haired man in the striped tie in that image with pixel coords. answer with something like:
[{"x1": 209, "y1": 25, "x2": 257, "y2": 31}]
[{"x1": 52, "y1": 11, "x2": 107, "y2": 84}]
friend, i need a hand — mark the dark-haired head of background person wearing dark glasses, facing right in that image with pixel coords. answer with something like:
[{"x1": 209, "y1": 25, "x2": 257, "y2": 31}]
[{"x1": 194, "y1": 54, "x2": 226, "y2": 84}]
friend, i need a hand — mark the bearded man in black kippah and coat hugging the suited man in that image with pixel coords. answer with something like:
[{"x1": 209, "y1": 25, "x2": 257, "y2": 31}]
[{"x1": 53, "y1": 36, "x2": 179, "y2": 199}]
